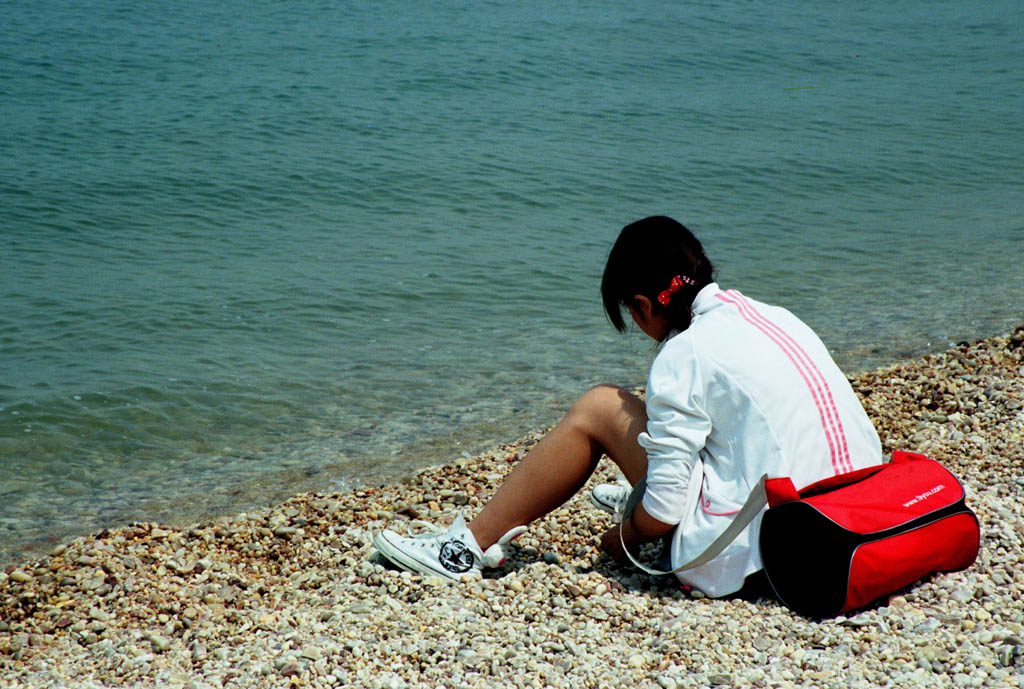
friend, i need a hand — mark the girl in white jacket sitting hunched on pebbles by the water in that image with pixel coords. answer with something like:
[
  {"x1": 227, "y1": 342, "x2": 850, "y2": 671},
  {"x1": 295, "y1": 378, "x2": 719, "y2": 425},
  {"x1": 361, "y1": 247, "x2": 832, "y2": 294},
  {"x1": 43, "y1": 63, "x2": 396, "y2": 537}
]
[{"x1": 374, "y1": 216, "x2": 882, "y2": 597}]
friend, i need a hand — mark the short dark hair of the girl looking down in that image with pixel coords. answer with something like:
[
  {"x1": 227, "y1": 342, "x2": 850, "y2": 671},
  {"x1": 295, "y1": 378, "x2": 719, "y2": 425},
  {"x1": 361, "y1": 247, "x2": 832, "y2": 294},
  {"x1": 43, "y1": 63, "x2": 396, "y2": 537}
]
[{"x1": 601, "y1": 215, "x2": 715, "y2": 332}]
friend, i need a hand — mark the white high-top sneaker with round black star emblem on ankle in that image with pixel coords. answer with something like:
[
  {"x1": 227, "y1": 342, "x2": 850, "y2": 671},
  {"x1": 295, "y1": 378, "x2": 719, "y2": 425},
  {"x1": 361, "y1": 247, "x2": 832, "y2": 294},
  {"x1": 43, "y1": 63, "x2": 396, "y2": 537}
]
[{"x1": 374, "y1": 513, "x2": 526, "y2": 582}]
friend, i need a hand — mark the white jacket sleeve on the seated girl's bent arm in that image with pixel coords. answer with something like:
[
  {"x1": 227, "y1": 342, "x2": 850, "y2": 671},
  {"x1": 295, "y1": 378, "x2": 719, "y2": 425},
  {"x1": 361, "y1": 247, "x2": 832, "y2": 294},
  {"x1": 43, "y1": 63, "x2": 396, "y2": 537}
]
[{"x1": 638, "y1": 340, "x2": 711, "y2": 524}]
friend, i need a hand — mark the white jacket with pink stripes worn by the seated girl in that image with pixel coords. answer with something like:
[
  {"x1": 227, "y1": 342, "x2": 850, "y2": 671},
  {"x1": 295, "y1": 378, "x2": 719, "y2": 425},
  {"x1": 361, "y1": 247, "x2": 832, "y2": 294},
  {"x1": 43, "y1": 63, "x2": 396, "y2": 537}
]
[{"x1": 639, "y1": 283, "x2": 882, "y2": 597}]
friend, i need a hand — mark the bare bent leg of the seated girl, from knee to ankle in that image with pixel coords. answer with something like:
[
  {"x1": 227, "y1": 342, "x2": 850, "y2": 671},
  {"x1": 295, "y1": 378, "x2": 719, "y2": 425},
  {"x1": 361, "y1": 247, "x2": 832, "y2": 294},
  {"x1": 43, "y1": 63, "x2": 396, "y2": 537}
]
[{"x1": 469, "y1": 385, "x2": 647, "y2": 550}]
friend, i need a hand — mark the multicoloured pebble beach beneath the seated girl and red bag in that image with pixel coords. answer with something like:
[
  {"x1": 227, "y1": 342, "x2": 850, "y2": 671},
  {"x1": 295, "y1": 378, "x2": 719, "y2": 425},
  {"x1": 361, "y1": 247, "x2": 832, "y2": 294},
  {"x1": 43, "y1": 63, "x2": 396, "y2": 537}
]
[{"x1": 0, "y1": 327, "x2": 1024, "y2": 689}]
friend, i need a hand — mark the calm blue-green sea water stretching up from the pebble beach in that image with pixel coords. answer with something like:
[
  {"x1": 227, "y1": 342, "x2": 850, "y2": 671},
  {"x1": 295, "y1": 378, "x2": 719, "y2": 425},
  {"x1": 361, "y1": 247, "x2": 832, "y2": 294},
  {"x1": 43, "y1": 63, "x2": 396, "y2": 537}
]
[{"x1": 0, "y1": 0, "x2": 1024, "y2": 561}]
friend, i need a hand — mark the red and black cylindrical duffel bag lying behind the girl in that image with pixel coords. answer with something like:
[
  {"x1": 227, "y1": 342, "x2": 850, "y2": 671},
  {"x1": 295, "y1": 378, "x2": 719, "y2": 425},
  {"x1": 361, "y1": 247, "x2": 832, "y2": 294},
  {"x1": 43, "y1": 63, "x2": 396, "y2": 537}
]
[{"x1": 760, "y1": 451, "x2": 981, "y2": 617}]
